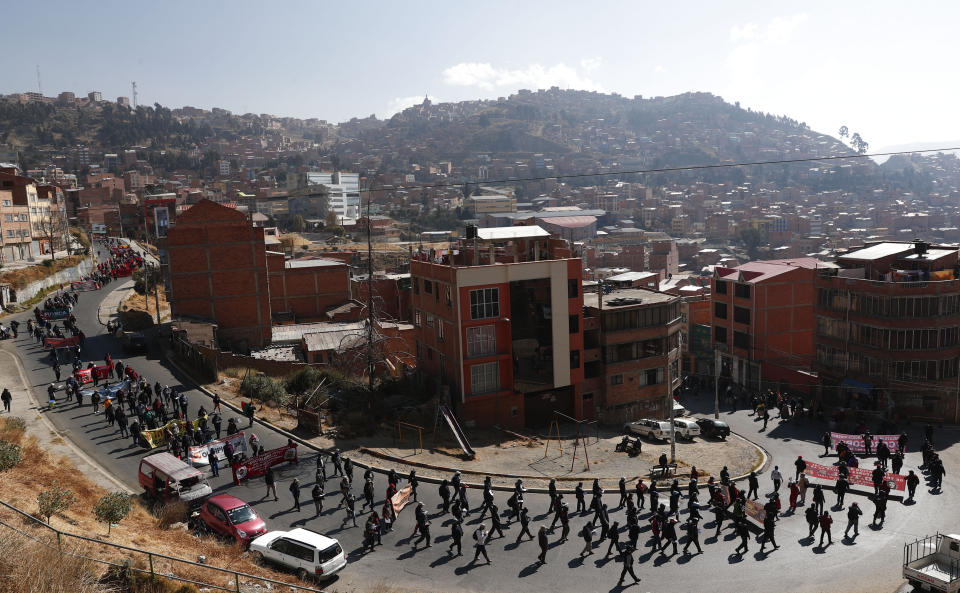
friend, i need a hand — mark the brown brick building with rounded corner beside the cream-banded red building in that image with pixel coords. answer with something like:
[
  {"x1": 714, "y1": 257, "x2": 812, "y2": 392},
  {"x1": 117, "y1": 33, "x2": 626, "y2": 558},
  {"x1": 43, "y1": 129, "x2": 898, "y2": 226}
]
[{"x1": 582, "y1": 288, "x2": 682, "y2": 424}]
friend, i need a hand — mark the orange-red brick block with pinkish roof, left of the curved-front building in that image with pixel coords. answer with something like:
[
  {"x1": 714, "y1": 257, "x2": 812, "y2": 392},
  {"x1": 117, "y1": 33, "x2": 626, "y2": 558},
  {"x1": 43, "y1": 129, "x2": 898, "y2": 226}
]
[{"x1": 710, "y1": 257, "x2": 820, "y2": 393}]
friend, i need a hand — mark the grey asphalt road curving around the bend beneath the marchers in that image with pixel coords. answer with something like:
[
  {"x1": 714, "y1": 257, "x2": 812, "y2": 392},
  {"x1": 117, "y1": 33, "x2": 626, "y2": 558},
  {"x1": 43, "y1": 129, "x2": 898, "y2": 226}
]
[{"x1": 0, "y1": 246, "x2": 960, "y2": 593}]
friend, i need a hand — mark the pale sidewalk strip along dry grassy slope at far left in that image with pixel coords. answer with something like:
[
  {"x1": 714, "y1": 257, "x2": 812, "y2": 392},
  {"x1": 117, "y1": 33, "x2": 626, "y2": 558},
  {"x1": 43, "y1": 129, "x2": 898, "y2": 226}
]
[{"x1": 0, "y1": 344, "x2": 133, "y2": 494}]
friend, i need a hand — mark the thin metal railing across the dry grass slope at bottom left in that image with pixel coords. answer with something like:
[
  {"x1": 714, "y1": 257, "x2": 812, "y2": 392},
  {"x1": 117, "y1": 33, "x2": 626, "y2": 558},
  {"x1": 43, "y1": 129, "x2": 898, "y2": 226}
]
[{"x1": 0, "y1": 500, "x2": 323, "y2": 593}]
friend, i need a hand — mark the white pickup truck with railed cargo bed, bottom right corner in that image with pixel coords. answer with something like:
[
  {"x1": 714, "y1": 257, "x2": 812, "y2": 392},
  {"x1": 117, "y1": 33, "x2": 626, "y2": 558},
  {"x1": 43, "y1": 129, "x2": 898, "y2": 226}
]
[{"x1": 903, "y1": 533, "x2": 960, "y2": 593}]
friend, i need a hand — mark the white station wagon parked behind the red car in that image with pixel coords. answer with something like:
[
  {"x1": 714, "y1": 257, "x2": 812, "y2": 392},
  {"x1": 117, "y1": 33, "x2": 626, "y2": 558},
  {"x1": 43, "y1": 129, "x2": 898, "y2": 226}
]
[{"x1": 250, "y1": 527, "x2": 347, "y2": 580}]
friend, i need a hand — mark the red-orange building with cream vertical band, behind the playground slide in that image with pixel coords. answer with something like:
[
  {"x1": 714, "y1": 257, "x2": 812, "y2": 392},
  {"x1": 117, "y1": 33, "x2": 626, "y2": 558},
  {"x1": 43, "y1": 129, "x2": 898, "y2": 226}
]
[{"x1": 410, "y1": 226, "x2": 580, "y2": 428}]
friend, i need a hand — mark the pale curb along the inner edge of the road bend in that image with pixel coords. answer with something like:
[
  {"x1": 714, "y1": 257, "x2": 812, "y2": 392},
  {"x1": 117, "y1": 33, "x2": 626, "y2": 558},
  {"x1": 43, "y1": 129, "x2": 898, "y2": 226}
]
[{"x1": 164, "y1": 353, "x2": 770, "y2": 495}]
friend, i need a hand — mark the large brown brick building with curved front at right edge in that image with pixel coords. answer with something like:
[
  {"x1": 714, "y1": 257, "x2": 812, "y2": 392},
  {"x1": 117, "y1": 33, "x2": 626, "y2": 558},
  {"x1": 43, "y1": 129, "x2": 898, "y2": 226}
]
[{"x1": 816, "y1": 241, "x2": 960, "y2": 422}]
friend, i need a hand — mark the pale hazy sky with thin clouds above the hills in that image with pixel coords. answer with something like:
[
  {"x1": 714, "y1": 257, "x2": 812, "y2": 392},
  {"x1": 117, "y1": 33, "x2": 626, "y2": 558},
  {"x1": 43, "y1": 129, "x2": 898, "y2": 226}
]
[{"x1": 0, "y1": 0, "x2": 960, "y2": 149}]
